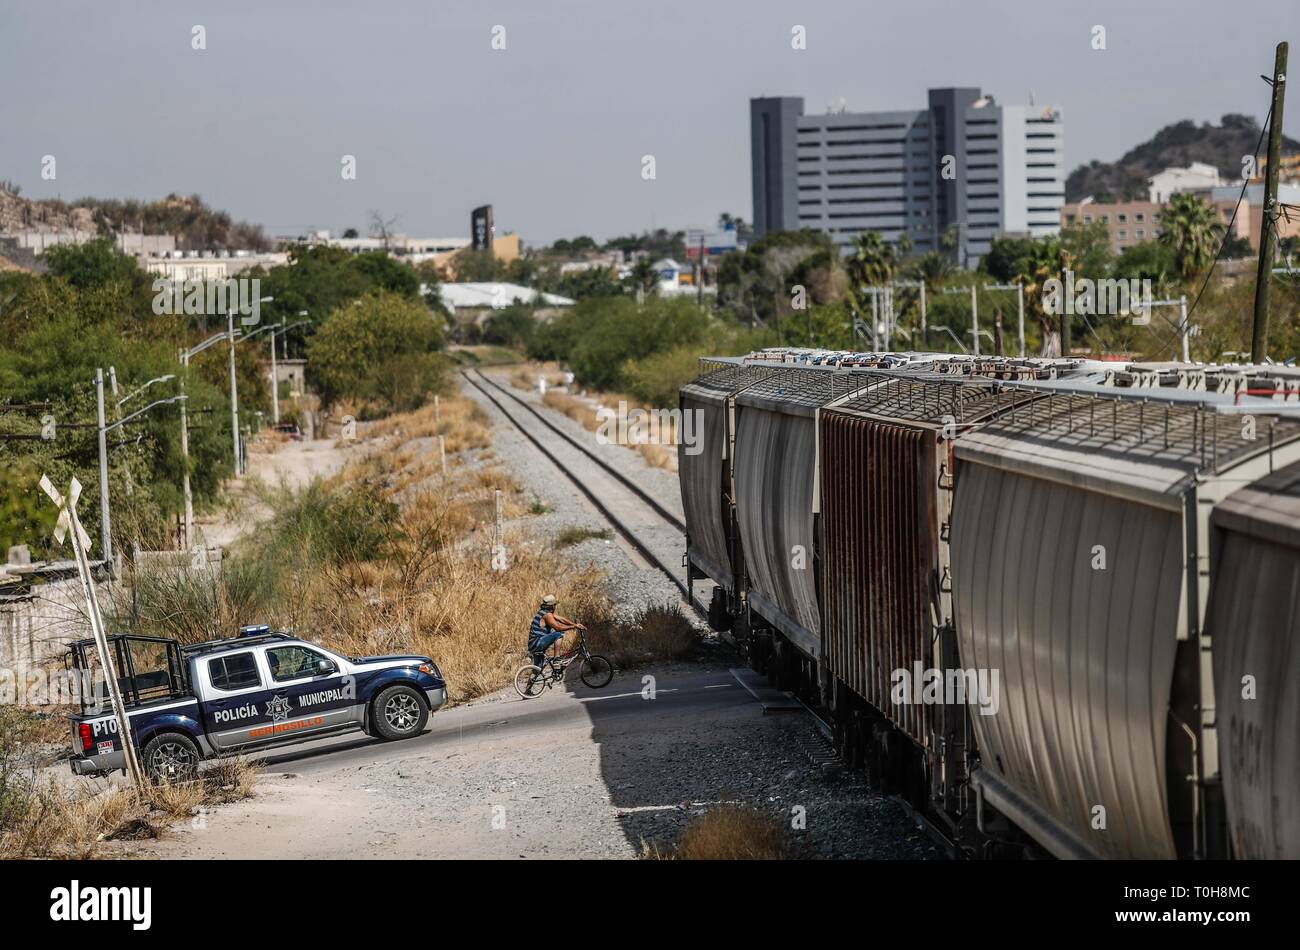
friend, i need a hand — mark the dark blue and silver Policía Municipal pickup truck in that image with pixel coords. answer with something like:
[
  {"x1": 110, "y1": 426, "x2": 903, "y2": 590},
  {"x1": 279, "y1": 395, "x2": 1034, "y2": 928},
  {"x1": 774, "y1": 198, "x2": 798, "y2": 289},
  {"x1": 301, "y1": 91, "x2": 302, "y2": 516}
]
[{"x1": 69, "y1": 626, "x2": 447, "y2": 781}]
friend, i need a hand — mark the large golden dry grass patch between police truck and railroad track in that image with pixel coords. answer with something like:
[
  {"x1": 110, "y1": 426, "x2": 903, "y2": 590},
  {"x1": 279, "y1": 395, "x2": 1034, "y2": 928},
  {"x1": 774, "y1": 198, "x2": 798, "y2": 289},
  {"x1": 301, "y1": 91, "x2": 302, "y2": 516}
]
[{"x1": 266, "y1": 396, "x2": 696, "y2": 703}]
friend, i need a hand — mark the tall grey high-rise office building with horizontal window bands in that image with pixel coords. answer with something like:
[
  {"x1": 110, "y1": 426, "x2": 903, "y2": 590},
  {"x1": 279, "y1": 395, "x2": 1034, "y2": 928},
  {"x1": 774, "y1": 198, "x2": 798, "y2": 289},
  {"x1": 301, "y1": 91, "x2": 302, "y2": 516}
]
[{"x1": 749, "y1": 88, "x2": 1065, "y2": 265}]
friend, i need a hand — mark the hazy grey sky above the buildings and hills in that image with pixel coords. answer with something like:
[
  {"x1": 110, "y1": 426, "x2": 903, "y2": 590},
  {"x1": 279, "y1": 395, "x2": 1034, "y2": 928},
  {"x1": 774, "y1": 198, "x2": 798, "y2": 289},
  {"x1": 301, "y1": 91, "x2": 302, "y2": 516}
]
[{"x1": 0, "y1": 0, "x2": 1300, "y2": 242}]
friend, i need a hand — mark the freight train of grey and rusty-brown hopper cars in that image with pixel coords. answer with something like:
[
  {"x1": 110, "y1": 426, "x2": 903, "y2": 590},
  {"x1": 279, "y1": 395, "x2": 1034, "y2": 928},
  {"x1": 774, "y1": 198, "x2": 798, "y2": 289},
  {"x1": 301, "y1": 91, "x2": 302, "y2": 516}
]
[{"x1": 679, "y1": 351, "x2": 1300, "y2": 858}]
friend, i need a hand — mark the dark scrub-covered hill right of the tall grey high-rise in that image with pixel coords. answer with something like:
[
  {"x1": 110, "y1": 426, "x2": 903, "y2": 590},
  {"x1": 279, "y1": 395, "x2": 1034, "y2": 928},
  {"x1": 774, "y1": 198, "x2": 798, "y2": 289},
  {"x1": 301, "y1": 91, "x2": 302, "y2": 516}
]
[{"x1": 1065, "y1": 113, "x2": 1300, "y2": 201}]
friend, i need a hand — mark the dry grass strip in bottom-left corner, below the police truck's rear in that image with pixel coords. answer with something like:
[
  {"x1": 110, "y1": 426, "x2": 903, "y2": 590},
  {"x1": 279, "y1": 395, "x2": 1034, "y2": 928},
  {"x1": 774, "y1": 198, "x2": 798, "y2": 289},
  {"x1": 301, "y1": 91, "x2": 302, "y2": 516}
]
[{"x1": 0, "y1": 759, "x2": 259, "y2": 860}]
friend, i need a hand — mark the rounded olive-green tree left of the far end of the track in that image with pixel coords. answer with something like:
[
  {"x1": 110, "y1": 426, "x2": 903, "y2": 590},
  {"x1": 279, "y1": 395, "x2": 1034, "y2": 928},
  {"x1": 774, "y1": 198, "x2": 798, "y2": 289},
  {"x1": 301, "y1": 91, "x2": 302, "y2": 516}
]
[{"x1": 307, "y1": 290, "x2": 447, "y2": 412}]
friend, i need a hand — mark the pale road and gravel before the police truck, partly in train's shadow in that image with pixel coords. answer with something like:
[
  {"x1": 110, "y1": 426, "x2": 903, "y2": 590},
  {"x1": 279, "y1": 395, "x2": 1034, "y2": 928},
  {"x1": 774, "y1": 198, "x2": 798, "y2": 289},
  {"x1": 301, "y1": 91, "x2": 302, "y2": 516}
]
[{"x1": 143, "y1": 664, "x2": 813, "y2": 858}]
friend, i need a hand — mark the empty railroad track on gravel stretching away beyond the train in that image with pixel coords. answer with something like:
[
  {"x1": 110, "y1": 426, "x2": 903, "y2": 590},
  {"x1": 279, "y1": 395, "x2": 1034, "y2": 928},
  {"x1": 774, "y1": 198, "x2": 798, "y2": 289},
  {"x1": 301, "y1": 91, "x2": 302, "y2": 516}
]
[{"x1": 462, "y1": 369, "x2": 705, "y2": 615}]
